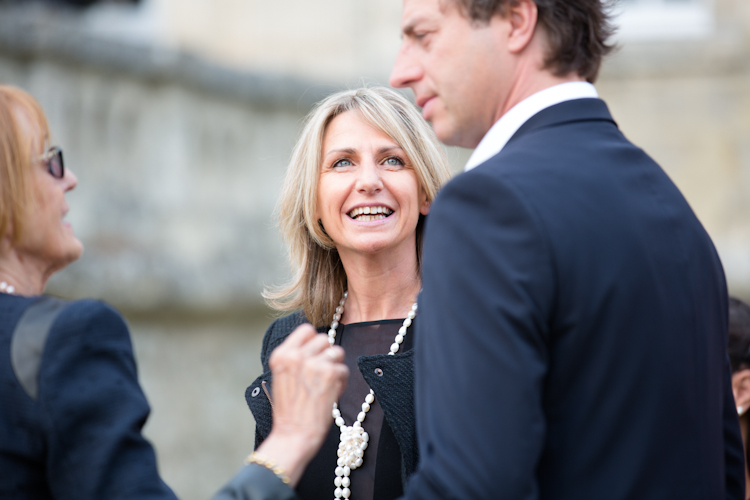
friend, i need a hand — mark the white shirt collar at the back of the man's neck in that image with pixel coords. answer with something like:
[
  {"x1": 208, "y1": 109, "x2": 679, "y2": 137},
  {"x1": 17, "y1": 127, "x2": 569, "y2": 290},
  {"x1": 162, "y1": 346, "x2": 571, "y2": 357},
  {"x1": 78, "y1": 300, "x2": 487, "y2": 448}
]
[{"x1": 464, "y1": 82, "x2": 599, "y2": 171}]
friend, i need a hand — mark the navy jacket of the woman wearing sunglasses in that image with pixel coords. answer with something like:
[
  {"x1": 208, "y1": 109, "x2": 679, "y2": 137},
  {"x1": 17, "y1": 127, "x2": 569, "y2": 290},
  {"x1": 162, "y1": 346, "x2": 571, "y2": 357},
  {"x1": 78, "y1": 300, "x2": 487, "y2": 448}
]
[{"x1": 0, "y1": 294, "x2": 294, "y2": 500}]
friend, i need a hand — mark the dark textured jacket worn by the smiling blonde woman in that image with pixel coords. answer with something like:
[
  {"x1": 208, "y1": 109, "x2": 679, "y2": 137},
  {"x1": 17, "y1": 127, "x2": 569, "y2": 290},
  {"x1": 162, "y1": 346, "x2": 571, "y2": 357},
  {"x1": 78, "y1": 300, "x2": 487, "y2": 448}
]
[{"x1": 245, "y1": 313, "x2": 419, "y2": 486}]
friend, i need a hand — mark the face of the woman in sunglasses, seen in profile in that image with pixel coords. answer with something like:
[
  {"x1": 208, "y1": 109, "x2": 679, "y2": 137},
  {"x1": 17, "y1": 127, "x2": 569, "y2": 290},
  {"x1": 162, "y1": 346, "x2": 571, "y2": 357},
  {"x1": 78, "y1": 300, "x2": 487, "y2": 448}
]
[{"x1": 14, "y1": 112, "x2": 83, "y2": 272}]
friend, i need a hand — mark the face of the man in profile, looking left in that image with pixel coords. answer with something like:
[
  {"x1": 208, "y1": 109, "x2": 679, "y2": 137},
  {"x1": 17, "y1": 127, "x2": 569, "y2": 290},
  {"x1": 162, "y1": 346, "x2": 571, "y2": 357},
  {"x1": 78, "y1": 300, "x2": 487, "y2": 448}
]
[{"x1": 390, "y1": 0, "x2": 507, "y2": 148}]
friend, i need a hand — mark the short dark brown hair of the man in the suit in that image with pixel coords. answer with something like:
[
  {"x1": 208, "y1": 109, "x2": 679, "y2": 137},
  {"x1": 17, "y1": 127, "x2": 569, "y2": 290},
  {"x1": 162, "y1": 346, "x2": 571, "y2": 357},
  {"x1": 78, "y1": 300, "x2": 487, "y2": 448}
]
[{"x1": 450, "y1": 0, "x2": 614, "y2": 83}]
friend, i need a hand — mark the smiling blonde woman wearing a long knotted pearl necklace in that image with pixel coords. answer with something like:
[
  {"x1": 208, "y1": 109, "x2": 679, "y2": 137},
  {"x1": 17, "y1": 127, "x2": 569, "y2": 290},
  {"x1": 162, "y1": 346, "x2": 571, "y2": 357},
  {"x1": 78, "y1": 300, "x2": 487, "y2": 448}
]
[{"x1": 246, "y1": 88, "x2": 450, "y2": 500}]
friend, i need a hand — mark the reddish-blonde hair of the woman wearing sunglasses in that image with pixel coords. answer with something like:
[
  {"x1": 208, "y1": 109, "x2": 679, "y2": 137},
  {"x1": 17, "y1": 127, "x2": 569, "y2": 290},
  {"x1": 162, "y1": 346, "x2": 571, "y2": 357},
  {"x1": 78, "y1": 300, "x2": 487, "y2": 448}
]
[{"x1": 0, "y1": 85, "x2": 49, "y2": 243}]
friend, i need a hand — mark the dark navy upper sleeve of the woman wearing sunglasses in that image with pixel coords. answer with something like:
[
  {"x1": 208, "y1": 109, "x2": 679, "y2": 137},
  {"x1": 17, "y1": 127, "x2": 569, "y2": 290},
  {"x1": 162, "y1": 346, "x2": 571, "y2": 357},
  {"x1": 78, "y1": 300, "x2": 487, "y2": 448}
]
[{"x1": 39, "y1": 301, "x2": 176, "y2": 500}]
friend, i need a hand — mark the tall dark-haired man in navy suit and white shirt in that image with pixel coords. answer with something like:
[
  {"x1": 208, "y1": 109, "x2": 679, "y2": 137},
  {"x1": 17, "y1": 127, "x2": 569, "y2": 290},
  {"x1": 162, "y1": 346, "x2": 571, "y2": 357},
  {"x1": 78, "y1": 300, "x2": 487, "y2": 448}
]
[{"x1": 391, "y1": 0, "x2": 744, "y2": 500}]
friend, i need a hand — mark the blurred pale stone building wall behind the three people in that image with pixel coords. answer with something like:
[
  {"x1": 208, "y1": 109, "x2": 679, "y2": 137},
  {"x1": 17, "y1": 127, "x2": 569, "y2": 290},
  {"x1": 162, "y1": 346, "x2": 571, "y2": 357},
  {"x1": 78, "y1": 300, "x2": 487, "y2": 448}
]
[{"x1": 0, "y1": 0, "x2": 750, "y2": 500}]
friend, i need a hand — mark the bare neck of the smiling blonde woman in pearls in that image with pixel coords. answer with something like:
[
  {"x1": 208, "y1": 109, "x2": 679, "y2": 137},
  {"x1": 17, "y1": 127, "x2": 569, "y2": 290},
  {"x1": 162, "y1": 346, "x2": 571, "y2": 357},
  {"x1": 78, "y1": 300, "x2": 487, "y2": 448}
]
[{"x1": 341, "y1": 250, "x2": 422, "y2": 323}]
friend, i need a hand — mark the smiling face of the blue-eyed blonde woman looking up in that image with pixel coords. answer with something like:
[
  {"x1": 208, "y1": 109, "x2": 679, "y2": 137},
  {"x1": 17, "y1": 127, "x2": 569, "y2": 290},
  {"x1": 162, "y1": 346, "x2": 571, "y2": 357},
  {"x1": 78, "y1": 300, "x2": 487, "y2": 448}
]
[{"x1": 316, "y1": 111, "x2": 430, "y2": 257}]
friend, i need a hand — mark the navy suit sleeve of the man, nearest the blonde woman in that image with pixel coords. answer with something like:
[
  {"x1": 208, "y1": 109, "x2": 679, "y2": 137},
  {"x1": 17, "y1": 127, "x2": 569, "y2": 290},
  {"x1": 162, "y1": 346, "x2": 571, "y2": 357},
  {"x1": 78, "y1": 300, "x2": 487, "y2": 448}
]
[{"x1": 407, "y1": 171, "x2": 555, "y2": 499}]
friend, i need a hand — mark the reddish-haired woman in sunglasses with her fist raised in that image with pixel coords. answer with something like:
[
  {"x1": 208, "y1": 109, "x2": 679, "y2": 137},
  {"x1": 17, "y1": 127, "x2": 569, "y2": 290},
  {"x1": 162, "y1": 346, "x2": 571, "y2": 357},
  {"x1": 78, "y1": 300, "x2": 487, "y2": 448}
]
[{"x1": 0, "y1": 86, "x2": 348, "y2": 500}]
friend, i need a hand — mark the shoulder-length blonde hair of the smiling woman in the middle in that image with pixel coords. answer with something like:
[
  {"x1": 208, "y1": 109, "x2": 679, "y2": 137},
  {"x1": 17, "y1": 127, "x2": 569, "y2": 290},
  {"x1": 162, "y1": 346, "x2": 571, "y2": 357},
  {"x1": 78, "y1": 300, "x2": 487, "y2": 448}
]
[{"x1": 263, "y1": 87, "x2": 450, "y2": 326}]
